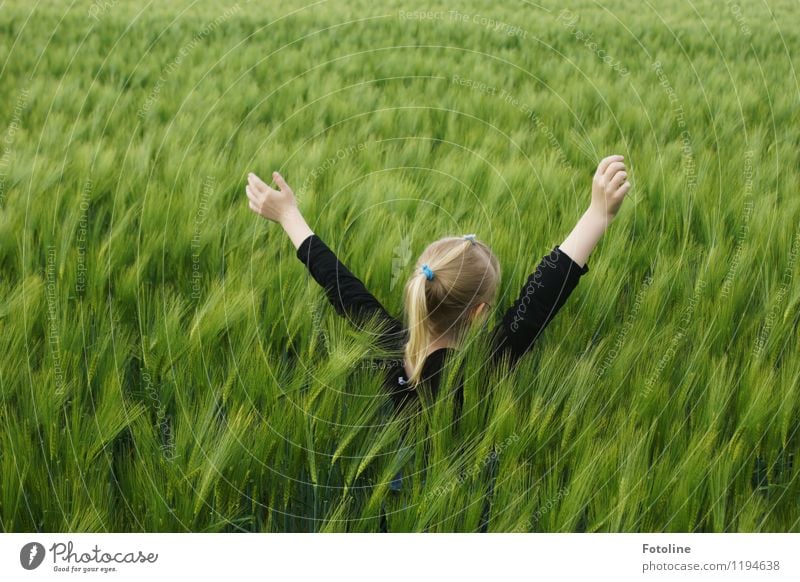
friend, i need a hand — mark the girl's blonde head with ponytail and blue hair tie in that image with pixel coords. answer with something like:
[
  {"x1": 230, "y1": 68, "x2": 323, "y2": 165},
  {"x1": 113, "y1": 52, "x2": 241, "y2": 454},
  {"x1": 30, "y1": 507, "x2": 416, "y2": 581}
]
[{"x1": 405, "y1": 235, "x2": 500, "y2": 383}]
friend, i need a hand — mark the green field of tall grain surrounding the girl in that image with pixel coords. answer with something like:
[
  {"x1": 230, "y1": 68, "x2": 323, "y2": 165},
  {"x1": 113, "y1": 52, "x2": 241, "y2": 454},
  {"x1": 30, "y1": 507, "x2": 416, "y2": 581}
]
[{"x1": 0, "y1": 0, "x2": 800, "y2": 532}]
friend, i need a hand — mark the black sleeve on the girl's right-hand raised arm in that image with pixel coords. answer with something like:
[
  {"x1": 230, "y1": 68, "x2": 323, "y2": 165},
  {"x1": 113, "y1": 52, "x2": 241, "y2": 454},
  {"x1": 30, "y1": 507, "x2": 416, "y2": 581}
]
[{"x1": 493, "y1": 246, "x2": 589, "y2": 364}]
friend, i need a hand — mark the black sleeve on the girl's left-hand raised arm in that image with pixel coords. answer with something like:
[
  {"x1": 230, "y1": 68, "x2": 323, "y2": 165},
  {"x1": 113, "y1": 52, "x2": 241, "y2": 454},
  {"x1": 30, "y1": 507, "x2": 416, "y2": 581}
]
[{"x1": 297, "y1": 234, "x2": 402, "y2": 338}]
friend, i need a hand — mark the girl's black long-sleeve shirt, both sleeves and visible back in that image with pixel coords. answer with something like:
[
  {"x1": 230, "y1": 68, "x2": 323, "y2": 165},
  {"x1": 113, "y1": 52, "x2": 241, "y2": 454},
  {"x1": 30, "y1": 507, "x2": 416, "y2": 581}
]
[{"x1": 297, "y1": 234, "x2": 589, "y2": 407}]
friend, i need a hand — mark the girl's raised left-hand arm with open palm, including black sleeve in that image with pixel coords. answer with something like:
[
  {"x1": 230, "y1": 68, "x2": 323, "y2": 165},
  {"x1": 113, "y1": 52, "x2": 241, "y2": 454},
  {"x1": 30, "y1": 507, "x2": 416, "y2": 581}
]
[{"x1": 246, "y1": 172, "x2": 402, "y2": 336}]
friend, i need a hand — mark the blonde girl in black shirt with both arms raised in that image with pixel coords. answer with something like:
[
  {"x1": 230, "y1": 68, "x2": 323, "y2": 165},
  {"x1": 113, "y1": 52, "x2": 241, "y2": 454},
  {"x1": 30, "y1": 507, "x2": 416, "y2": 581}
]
[{"x1": 245, "y1": 155, "x2": 631, "y2": 407}]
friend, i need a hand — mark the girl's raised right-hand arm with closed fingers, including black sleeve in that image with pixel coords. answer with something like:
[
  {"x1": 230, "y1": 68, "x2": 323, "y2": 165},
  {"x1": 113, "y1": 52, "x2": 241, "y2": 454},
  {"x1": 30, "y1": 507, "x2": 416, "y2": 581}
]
[{"x1": 494, "y1": 156, "x2": 630, "y2": 363}]
